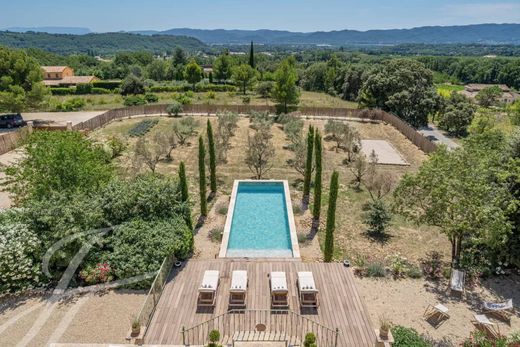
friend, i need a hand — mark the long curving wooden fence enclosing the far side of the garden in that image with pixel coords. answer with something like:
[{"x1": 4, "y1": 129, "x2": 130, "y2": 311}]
[{"x1": 73, "y1": 104, "x2": 437, "y2": 153}]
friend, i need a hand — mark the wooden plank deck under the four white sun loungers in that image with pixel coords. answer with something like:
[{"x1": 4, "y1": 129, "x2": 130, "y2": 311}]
[{"x1": 145, "y1": 259, "x2": 376, "y2": 347}]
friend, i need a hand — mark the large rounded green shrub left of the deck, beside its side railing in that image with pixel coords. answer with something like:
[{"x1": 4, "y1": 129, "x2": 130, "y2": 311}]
[{"x1": 105, "y1": 217, "x2": 193, "y2": 288}]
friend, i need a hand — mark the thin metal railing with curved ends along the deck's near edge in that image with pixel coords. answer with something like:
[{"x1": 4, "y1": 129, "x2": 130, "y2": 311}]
[{"x1": 180, "y1": 309, "x2": 340, "y2": 347}]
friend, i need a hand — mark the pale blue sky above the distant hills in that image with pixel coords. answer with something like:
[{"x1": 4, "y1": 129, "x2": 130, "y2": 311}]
[{"x1": 0, "y1": 0, "x2": 520, "y2": 32}]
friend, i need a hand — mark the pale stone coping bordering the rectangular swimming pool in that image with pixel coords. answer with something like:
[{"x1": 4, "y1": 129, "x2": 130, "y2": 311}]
[{"x1": 218, "y1": 180, "x2": 300, "y2": 260}]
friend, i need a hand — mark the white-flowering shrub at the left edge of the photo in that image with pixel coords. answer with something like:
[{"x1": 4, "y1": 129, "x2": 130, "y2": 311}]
[{"x1": 0, "y1": 223, "x2": 43, "y2": 293}]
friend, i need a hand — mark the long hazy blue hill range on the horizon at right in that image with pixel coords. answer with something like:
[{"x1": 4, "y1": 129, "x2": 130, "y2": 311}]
[{"x1": 151, "y1": 24, "x2": 520, "y2": 45}]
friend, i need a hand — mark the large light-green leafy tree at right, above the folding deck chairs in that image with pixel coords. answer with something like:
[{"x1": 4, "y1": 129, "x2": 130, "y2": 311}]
[{"x1": 394, "y1": 132, "x2": 511, "y2": 266}]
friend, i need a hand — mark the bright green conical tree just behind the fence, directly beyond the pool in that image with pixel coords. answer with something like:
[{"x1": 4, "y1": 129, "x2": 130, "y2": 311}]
[{"x1": 272, "y1": 57, "x2": 300, "y2": 113}]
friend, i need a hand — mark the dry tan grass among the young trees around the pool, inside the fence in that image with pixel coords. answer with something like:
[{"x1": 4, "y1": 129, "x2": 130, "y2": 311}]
[{"x1": 91, "y1": 117, "x2": 449, "y2": 266}]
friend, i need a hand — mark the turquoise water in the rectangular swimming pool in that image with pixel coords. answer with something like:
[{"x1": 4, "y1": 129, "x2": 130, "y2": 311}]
[{"x1": 226, "y1": 182, "x2": 292, "y2": 257}]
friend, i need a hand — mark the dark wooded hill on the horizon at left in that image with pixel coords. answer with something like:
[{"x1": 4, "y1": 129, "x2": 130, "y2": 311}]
[{"x1": 0, "y1": 31, "x2": 206, "y2": 55}]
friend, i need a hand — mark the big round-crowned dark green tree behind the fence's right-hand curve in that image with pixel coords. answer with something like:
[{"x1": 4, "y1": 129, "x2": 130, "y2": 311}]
[{"x1": 359, "y1": 59, "x2": 440, "y2": 127}]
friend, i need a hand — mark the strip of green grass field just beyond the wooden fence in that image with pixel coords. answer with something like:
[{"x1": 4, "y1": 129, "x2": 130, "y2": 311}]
[{"x1": 49, "y1": 91, "x2": 357, "y2": 111}]
